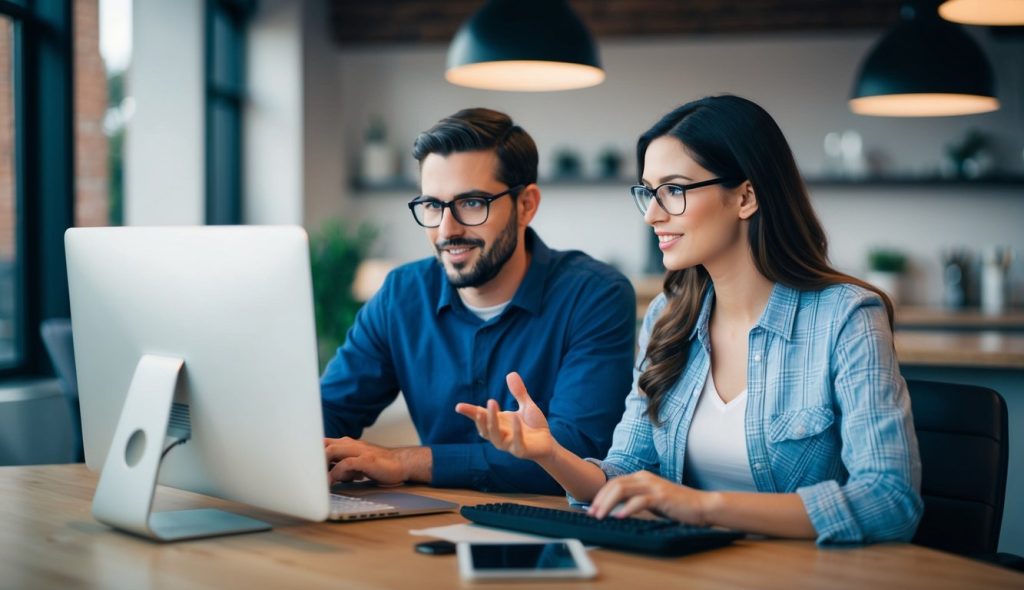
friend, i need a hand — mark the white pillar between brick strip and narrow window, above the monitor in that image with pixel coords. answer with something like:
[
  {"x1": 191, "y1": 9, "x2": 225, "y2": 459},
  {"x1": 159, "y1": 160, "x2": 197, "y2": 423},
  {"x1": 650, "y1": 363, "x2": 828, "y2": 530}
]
[{"x1": 125, "y1": 0, "x2": 206, "y2": 225}]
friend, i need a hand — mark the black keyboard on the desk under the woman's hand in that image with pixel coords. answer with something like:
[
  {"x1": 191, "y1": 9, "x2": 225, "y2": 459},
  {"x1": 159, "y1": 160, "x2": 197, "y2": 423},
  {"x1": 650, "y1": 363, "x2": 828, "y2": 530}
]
[{"x1": 460, "y1": 502, "x2": 743, "y2": 555}]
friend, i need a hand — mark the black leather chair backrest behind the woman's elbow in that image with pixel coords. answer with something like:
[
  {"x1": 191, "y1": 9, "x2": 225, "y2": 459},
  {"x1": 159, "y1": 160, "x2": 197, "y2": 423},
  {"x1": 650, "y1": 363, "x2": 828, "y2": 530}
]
[{"x1": 907, "y1": 380, "x2": 1009, "y2": 556}]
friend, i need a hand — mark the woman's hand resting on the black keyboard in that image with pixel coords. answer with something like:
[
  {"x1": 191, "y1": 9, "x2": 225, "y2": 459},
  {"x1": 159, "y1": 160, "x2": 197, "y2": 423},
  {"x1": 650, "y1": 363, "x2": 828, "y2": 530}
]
[{"x1": 587, "y1": 471, "x2": 711, "y2": 526}]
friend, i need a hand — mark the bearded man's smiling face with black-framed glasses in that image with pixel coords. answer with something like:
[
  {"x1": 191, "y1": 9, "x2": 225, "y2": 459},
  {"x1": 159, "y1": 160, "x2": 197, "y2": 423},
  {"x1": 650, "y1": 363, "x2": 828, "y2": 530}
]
[{"x1": 420, "y1": 150, "x2": 519, "y2": 289}]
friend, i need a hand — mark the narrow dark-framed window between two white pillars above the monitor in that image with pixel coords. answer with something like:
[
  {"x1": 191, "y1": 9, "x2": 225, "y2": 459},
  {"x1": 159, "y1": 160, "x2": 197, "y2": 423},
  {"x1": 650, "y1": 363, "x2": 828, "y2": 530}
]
[{"x1": 206, "y1": 0, "x2": 253, "y2": 224}]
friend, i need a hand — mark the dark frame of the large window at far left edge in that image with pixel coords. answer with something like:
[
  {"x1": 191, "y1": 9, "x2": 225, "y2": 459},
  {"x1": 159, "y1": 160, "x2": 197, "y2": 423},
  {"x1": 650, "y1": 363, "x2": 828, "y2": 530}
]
[{"x1": 0, "y1": 0, "x2": 75, "y2": 380}]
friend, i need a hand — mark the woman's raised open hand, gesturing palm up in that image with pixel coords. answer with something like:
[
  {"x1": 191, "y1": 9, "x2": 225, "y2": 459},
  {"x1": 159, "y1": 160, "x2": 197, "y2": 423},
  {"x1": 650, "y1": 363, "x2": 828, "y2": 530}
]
[{"x1": 455, "y1": 373, "x2": 556, "y2": 460}]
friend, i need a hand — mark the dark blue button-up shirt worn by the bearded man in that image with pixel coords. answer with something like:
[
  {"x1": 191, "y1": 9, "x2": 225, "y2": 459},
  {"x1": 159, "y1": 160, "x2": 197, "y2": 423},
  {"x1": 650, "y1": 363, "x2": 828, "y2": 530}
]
[{"x1": 321, "y1": 228, "x2": 636, "y2": 494}]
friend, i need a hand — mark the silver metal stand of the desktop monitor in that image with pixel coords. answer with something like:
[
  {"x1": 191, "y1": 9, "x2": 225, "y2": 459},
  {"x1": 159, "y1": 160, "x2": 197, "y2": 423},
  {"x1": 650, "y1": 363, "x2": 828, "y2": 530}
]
[{"x1": 92, "y1": 354, "x2": 270, "y2": 541}]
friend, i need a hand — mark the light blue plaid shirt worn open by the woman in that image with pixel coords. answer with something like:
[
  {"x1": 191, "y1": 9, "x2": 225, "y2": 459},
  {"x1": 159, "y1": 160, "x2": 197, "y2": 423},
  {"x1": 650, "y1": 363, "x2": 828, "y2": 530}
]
[{"x1": 590, "y1": 284, "x2": 924, "y2": 544}]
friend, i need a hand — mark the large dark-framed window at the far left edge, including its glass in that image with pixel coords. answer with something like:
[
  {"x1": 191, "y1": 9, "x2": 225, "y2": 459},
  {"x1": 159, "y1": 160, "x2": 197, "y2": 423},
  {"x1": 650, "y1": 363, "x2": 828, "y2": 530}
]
[{"x1": 0, "y1": 0, "x2": 74, "y2": 377}]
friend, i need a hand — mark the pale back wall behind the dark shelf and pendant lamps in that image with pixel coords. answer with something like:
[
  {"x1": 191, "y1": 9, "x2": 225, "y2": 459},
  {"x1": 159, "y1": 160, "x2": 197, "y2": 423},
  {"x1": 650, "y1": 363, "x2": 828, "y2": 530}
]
[{"x1": 329, "y1": 32, "x2": 1024, "y2": 303}]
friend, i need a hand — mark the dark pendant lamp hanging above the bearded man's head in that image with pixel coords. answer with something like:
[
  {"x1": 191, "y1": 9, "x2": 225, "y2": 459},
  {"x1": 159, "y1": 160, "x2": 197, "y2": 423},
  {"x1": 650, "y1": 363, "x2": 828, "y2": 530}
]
[{"x1": 444, "y1": 0, "x2": 604, "y2": 92}]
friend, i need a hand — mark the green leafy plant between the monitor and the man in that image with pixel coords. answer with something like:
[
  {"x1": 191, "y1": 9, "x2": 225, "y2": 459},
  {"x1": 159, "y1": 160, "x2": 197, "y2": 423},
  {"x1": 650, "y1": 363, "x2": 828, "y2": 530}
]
[{"x1": 309, "y1": 219, "x2": 377, "y2": 371}]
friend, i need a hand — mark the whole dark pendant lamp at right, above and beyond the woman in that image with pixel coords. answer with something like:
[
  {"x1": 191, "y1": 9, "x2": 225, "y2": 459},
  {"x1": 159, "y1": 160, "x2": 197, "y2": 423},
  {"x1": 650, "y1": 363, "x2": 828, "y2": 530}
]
[{"x1": 850, "y1": 0, "x2": 999, "y2": 117}]
